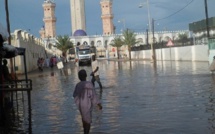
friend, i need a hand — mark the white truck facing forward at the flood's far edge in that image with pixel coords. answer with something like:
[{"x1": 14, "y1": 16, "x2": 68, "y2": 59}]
[{"x1": 77, "y1": 45, "x2": 95, "y2": 65}]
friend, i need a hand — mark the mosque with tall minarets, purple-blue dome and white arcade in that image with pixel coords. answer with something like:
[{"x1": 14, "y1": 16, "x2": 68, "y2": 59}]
[{"x1": 40, "y1": 0, "x2": 189, "y2": 57}]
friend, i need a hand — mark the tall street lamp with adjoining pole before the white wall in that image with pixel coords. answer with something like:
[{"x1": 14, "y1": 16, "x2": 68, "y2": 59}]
[{"x1": 139, "y1": 0, "x2": 156, "y2": 64}]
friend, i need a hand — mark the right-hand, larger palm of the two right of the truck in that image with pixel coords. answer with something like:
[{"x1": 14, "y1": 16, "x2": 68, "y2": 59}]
[{"x1": 122, "y1": 29, "x2": 138, "y2": 60}]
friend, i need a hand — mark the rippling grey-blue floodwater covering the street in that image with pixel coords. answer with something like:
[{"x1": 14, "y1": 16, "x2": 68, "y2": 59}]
[{"x1": 4, "y1": 60, "x2": 215, "y2": 134}]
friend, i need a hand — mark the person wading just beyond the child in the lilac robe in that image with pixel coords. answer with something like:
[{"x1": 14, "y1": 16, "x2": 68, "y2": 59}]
[{"x1": 91, "y1": 55, "x2": 102, "y2": 91}]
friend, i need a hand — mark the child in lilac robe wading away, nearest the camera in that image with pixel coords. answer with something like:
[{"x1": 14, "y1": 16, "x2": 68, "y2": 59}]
[{"x1": 73, "y1": 69, "x2": 102, "y2": 134}]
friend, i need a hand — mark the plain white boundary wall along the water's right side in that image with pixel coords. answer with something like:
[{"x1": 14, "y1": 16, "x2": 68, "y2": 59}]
[{"x1": 131, "y1": 45, "x2": 208, "y2": 61}]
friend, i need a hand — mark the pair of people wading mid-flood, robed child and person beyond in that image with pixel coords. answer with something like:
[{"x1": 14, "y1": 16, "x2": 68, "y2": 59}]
[{"x1": 73, "y1": 55, "x2": 102, "y2": 134}]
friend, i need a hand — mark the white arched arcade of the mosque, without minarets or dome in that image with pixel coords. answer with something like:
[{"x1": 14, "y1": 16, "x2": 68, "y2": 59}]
[{"x1": 70, "y1": 30, "x2": 190, "y2": 58}]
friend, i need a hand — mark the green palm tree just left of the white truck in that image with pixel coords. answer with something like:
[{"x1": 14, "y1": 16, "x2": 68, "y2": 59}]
[{"x1": 56, "y1": 35, "x2": 74, "y2": 62}]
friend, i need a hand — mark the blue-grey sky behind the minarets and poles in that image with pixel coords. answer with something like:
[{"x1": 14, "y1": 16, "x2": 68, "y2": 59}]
[{"x1": 0, "y1": 0, "x2": 215, "y2": 38}]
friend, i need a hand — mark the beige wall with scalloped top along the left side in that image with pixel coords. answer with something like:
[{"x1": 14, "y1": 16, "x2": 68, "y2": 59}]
[{"x1": 8, "y1": 30, "x2": 53, "y2": 74}]
